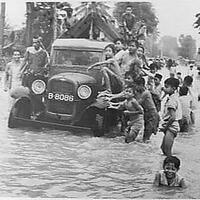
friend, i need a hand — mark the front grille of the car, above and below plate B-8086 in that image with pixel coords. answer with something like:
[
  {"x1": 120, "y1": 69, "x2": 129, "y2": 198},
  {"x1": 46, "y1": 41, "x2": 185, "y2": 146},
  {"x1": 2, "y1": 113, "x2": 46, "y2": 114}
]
[{"x1": 47, "y1": 80, "x2": 74, "y2": 115}]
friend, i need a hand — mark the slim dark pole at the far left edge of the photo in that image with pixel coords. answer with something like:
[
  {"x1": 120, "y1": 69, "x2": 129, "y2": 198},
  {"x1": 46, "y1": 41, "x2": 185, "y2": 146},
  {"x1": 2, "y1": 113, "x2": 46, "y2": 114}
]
[{"x1": 0, "y1": 2, "x2": 6, "y2": 57}]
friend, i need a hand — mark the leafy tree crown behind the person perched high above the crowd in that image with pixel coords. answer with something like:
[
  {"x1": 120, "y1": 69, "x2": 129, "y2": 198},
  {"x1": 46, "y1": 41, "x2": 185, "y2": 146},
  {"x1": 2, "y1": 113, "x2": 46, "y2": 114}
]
[{"x1": 113, "y1": 2, "x2": 158, "y2": 33}]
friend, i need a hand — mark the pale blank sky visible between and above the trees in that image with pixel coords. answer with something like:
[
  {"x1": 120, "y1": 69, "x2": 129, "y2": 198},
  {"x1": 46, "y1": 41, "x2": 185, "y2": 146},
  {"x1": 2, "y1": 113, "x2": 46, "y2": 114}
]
[{"x1": 3, "y1": 0, "x2": 200, "y2": 44}]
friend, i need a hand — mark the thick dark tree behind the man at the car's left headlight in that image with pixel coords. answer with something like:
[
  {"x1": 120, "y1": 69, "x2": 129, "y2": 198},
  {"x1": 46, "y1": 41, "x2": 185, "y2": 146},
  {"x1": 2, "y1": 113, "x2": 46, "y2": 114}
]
[{"x1": 26, "y1": 2, "x2": 71, "y2": 49}]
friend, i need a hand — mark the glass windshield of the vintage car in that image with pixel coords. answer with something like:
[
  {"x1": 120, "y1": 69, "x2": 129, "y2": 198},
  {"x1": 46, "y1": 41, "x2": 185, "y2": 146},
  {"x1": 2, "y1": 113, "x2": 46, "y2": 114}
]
[{"x1": 53, "y1": 49, "x2": 102, "y2": 66}]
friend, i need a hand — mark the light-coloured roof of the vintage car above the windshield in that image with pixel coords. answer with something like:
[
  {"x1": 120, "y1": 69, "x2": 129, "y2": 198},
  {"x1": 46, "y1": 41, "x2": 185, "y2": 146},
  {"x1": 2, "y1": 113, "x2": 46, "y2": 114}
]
[{"x1": 52, "y1": 38, "x2": 112, "y2": 51}]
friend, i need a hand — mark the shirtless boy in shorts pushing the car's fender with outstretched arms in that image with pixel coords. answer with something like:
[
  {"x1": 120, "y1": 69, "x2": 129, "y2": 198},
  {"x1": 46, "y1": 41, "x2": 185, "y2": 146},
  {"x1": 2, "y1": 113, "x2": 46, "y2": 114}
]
[{"x1": 110, "y1": 85, "x2": 144, "y2": 143}]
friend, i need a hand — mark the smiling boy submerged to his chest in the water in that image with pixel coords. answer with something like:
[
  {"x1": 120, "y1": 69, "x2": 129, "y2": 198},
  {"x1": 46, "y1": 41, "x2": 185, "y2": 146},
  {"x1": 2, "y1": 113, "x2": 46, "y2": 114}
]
[{"x1": 154, "y1": 156, "x2": 186, "y2": 188}]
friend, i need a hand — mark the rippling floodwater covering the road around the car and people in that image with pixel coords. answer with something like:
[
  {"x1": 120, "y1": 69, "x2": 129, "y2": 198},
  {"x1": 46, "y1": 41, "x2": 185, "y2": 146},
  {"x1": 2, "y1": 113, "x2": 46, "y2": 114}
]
[{"x1": 0, "y1": 67, "x2": 200, "y2": 199}]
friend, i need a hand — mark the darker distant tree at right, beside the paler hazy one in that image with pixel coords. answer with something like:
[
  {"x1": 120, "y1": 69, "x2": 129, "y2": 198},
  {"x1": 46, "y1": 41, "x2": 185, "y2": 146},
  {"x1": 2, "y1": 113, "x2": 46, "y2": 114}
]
[{"x1": 179, "y1": 34, "x2": 196, "y2": 59}]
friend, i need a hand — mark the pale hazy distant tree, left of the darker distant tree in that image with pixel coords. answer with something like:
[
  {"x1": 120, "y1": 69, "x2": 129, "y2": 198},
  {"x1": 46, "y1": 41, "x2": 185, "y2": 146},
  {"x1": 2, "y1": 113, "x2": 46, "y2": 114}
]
[{"x1": 160, "y1": 36, "x2": 178, "y2": 58}]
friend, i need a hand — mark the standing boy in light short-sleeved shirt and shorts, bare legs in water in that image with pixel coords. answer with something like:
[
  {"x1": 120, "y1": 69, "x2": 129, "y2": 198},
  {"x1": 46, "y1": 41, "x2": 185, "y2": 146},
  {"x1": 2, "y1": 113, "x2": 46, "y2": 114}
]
[{"x1": 160, "y1": 78, "x2": 182, "y2": 156}]
